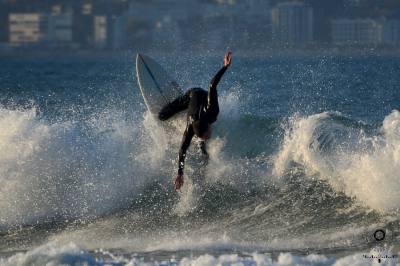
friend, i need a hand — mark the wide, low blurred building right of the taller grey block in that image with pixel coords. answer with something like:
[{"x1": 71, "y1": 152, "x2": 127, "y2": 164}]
[{"x1": 331, "y1": 19, "x2": 383, "y2": 46}]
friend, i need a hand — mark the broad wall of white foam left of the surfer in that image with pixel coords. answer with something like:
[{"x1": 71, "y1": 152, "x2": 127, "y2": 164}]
[{"x1": 0, "y1": 109, "x2": 165, "y2": 227}]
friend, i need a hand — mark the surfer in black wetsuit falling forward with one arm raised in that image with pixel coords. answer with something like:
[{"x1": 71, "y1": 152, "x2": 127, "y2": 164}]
[{"x1": 158, "y1": 52, "x2": 232, "y2": 190}]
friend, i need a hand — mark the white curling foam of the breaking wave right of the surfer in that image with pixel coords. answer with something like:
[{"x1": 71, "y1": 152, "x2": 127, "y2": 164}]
[{"x1": 274, "y1": 111, "x2": 400, "y2": 211}]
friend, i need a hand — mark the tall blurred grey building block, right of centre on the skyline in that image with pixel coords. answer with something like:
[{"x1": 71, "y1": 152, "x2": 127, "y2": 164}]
[{"x1": 271, "y1": 2, "x2": 313, "y2": 46}]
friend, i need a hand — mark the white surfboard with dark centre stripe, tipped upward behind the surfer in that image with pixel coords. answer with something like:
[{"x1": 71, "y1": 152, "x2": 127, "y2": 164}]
[{"x1": 136, "y1": 54, "x2": 183, "y2": 117}]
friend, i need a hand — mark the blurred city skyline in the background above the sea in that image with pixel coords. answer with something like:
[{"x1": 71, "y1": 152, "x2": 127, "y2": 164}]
[{"x1": 0, "y1": 0, "x2": 400, "y2": 54}]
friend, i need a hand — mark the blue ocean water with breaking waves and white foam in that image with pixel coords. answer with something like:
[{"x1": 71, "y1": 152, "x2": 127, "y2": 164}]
[{"x1": 0, "y1": 54, "x2": 400, "y2": 265}]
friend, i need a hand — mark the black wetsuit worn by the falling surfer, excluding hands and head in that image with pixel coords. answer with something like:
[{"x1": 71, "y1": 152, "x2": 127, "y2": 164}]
[{"x1": 159, "y1": 67, "x2": 227, "y2": 175}]
